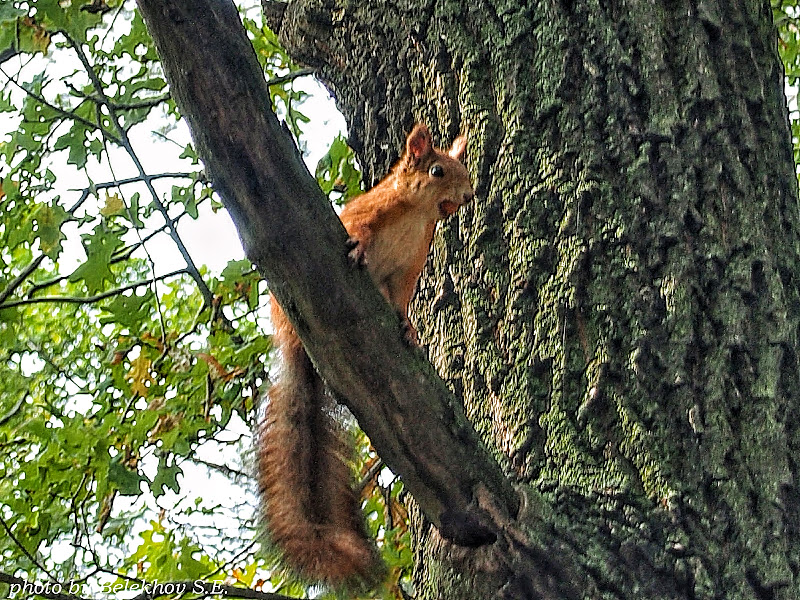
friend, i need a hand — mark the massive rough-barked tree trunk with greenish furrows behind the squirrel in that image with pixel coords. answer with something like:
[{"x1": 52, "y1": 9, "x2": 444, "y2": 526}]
[{"x1": 265, "y1": 0, "x2": 800, "y2": 599}]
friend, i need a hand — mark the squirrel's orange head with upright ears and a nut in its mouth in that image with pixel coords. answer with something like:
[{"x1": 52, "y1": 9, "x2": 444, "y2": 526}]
[{"x1": 398, "y1": 123, "x2": 475, "y2": 219}]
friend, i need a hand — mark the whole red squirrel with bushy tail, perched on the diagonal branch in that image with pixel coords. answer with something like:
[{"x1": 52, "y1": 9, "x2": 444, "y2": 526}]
[{"x1": 258, "y1": 124, "x2": 473, "y2": 585}]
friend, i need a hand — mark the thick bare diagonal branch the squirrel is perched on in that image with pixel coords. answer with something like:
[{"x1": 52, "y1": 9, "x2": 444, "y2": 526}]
[{"x1": 139, "y1": 0, "x2": 518, "y2": 533}]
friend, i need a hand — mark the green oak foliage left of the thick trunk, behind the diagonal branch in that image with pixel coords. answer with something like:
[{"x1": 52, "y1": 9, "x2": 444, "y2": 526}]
[{"x1": 0, "y1": 0, "x2": 400, "y2": 598}]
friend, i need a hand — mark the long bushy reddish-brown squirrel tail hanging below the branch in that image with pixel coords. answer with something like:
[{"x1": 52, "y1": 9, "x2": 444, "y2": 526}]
[{"x1": 257, "y1": 299, "x2": 380, "y2": 585}]
